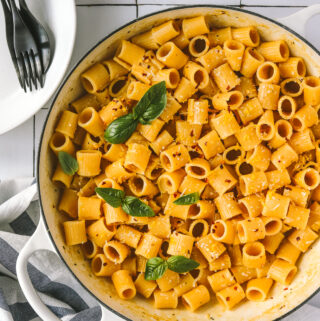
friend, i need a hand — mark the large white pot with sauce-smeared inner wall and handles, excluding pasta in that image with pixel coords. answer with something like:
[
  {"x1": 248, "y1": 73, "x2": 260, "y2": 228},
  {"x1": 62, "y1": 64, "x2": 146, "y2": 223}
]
[{"x1": 17, "y1": 5, "x2": 320, "y2": 321}]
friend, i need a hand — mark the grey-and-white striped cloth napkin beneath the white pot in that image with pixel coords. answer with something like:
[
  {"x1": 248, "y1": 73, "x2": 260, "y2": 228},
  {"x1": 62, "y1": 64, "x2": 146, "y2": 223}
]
[{"x1": 0, "y1": 178, "x2": 320, "y2": 321}]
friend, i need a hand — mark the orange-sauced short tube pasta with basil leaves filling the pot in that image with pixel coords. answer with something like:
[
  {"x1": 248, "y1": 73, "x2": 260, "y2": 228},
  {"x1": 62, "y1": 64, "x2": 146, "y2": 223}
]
[{"x1": 49, "y1": 16, "x2": 320, "y2": 311}]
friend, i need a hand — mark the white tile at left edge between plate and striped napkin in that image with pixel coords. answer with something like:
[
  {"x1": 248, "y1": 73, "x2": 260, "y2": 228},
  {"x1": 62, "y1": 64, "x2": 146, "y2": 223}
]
[{"x1": 0, "y1": 117, "x2": 34, "y2": 180}]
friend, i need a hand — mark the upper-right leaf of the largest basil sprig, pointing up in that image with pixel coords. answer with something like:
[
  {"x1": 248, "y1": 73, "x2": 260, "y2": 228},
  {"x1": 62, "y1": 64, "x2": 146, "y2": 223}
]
[{"x1": 133, "y1": 81, "x2": 167, "y2": 124}]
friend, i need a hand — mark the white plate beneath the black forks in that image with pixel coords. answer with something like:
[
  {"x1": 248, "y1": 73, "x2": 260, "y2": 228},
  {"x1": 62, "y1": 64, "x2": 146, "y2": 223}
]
[{"x1": 0, "y1": 0, "x2": 76, "y2": 135}]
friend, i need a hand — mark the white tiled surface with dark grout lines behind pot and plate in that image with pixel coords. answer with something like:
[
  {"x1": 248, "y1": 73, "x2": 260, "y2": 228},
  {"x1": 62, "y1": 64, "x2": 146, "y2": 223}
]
[{"x1": 0, "y1": 0, "x2": 320, "y2": 321}]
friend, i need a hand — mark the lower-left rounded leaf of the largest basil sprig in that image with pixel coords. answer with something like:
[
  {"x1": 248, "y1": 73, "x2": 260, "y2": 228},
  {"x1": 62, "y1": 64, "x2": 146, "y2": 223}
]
[{"x1": 104, "y1": 114, "x2": 138, "y2": 144}]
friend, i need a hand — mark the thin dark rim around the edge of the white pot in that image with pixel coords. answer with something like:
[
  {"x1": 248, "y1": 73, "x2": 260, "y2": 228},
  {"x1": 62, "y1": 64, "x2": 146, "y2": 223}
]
[{"x1": 36, "y1": 5, "x2": 320, "y2": 321}]
